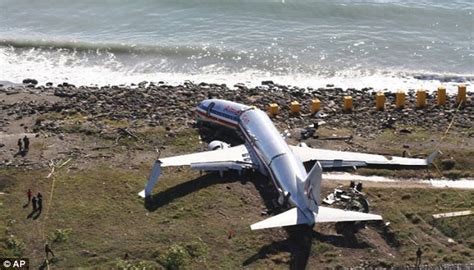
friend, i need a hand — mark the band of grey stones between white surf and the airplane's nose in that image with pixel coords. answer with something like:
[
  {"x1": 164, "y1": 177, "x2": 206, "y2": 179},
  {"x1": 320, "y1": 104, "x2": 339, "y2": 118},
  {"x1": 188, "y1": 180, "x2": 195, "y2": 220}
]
[{"x1": 0, "y1": 81, "x2": 474, "y2": 137}]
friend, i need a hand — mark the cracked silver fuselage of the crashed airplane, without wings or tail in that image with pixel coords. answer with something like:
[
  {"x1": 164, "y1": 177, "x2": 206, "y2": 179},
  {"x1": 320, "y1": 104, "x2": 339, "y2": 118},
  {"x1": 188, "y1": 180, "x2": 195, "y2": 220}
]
[{"x1": 197, "y1": 99, "x2": 314, "y2": 220}]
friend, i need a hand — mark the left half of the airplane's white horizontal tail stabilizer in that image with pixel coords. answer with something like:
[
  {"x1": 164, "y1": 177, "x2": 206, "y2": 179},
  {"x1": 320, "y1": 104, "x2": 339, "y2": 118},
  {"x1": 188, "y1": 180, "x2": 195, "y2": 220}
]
[{"x1": 250, "y1": 207, "x2": 313, "y2": 230}]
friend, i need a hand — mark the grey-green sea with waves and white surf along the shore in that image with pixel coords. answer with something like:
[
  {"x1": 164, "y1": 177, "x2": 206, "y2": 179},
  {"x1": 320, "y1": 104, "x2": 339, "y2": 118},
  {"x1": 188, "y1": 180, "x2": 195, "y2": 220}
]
[{"x1": 0, "y1": 0, "x2": 474, "y2": 90}]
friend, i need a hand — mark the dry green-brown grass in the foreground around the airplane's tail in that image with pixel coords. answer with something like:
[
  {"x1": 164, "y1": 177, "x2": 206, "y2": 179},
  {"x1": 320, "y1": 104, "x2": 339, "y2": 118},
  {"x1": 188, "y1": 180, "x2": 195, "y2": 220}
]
[{"x1": 0, "y1": 164, "x2": 474, "y2": 268}]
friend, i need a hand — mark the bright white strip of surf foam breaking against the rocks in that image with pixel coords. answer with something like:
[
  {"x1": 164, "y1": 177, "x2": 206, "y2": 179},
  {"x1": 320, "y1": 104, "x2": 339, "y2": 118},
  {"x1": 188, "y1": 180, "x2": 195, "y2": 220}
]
[{"x1": 0, "y1": 73, "x2": 474, "y2": 95}]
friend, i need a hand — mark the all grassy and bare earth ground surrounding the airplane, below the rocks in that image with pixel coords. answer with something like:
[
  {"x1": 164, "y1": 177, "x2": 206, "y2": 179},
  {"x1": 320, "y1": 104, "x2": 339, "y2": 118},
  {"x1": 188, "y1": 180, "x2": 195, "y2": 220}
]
[{"x1": 0, "y1": 114, "x2": 474, "y2": 269}]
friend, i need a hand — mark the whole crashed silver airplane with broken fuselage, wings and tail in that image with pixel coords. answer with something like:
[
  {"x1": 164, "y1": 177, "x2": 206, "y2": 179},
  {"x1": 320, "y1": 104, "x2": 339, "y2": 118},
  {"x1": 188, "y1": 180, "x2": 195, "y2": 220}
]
[{"x1": 139, "y1": 99, "x2": 438, "y2": 230}]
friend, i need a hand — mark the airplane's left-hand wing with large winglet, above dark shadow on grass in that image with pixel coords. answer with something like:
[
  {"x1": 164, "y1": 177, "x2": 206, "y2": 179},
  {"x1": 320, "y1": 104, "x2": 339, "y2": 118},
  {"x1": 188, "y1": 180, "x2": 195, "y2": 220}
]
[{"x1": 138, "y1": 145, "x2": 255, "y2": 198}]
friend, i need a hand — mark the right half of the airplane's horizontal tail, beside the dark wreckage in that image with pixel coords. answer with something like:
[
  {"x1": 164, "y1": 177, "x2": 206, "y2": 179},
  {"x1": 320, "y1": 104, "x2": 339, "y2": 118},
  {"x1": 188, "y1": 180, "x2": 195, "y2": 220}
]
[{"x1": 315, "y1": 206, "x2": 382, "y2": 223}]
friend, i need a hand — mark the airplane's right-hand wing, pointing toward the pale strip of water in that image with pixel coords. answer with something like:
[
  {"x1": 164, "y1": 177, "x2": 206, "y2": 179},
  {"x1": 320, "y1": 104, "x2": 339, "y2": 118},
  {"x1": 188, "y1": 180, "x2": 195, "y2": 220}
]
[{"x1": 290, "y1": 146, "x2": 439, "y2": 168}]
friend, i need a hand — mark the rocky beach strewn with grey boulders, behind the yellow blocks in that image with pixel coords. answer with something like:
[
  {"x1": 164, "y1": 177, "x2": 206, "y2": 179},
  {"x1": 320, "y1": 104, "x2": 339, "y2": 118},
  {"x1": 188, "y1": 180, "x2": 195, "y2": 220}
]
[{"x1": 0, "y1": 79, "x2": 474, "y2": 172}]
